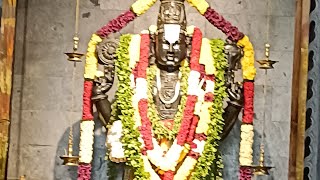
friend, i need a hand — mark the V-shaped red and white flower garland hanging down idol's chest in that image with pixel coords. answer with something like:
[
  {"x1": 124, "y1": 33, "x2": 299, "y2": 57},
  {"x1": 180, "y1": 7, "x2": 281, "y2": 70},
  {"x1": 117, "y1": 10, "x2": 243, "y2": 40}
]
[{"x1": 122, "y1": 26, "x2": 224, "y2": 179}]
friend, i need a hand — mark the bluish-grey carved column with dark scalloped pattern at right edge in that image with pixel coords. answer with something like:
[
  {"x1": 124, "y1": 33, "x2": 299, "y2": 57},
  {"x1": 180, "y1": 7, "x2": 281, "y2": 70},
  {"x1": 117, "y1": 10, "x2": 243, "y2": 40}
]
[{"x1": 304, "y1": 0, "x2": 320, "y2": 180}]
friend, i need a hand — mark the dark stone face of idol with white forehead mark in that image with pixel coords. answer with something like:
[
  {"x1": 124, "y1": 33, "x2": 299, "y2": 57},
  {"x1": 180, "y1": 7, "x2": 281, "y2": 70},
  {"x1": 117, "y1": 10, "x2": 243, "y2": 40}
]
[{"x1": 155, "y1": 24, "x2": 187, "y2": 68}]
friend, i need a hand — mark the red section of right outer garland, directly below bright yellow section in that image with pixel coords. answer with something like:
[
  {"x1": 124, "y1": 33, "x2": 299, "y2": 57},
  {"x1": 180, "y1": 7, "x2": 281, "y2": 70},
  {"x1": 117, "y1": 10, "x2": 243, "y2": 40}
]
[{"x1": 242, "y1": 81, "x2": 254, "y2": 124}]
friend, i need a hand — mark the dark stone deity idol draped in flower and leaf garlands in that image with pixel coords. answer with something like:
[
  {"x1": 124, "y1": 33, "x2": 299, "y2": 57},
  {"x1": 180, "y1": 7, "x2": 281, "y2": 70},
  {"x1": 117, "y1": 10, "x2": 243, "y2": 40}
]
[{"x1": 79, "y1": 0, "x2": 258, "y2": 179}]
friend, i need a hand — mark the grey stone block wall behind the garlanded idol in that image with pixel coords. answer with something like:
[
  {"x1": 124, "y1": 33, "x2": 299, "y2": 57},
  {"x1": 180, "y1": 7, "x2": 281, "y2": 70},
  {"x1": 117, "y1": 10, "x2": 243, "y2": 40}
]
[{"x1": 8, "y1": 0, "x2": 295, "y2": 180}]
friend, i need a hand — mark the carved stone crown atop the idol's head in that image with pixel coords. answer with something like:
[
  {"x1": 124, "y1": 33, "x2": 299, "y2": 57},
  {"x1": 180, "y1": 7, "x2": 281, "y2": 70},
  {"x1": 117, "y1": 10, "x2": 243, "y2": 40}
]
[{"x1": 157, "y1": 0, "x2": 187, "y2": 30}]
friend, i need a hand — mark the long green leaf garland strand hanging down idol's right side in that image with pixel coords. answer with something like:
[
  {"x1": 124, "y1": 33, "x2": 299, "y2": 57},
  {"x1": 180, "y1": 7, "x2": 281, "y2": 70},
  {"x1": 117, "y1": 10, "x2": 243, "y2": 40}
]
[{"x1": 191, "y1": 39, "x2": 228, "y2": 180}]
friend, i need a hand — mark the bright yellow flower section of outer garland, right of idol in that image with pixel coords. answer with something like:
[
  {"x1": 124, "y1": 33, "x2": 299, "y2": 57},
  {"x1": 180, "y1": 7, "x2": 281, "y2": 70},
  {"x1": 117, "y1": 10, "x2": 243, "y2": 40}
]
[{"x1": 237, "y1": 36, "x2": 256, "y2": 80}]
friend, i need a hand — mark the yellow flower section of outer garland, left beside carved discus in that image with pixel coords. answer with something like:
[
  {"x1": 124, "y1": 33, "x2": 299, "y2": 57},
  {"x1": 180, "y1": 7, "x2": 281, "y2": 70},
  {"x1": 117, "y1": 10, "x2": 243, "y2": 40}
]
[{"x1": 84, "y1": 34, "x2": 102, "y2": 79}]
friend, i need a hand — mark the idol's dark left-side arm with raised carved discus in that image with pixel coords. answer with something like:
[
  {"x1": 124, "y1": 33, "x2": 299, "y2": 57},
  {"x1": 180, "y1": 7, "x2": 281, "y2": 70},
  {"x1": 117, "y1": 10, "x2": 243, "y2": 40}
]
[{"x1": 92, "y1": 38, "x2": 119, "y2": 126}]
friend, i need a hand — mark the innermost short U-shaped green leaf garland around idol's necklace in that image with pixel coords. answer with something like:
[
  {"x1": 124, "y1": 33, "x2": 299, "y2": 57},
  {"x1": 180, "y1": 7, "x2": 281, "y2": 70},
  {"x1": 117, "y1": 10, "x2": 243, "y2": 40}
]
[{"x1": 147, "y1": 61, "x2": 190, "y2": 140}]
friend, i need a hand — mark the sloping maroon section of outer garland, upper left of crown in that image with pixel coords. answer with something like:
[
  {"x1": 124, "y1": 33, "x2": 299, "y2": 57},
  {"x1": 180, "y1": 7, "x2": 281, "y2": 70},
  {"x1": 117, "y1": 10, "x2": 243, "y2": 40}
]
[{"x1": 97, "y1": 10, "x2": 136, "y2": 38}]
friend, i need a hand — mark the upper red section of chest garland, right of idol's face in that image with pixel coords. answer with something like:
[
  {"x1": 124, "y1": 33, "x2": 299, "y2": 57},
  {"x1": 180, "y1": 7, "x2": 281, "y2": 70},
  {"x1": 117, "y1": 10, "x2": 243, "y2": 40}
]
[{"x1": 190, "y1": 28, "x2": 202, "y2": 72}]
